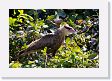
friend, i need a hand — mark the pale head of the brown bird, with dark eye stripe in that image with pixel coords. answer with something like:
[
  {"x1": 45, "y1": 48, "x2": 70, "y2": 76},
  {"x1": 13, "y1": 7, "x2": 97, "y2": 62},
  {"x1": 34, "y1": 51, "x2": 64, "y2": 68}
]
[{"x1": 61, "y1": 24, "x2": 76, "y2": 36}]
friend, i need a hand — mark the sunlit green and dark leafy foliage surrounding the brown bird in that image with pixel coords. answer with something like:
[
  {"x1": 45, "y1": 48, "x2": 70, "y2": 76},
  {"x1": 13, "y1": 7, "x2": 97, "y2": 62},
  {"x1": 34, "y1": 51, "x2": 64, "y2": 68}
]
[{"x1": 9, "y1": 9, "x2": 99, "y2": 68}]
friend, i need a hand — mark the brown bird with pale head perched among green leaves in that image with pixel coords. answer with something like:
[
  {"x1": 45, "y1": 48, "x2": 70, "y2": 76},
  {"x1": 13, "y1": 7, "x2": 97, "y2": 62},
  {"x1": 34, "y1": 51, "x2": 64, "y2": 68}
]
[{"x1": 19, "y1": 23, "x2": 76, "y2": 57}]
